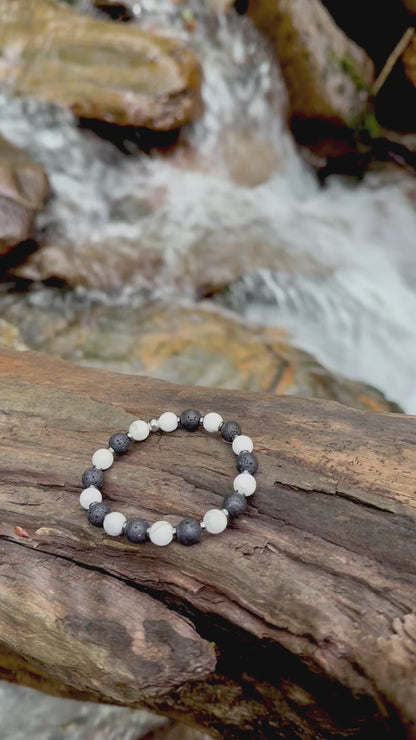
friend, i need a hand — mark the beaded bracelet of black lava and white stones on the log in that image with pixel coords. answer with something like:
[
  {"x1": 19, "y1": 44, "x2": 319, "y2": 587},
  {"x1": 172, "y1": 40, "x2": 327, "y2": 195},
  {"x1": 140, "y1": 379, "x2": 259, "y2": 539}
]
[{"x1": 80, "y1": 409, "x2": 258, "y2": 545}]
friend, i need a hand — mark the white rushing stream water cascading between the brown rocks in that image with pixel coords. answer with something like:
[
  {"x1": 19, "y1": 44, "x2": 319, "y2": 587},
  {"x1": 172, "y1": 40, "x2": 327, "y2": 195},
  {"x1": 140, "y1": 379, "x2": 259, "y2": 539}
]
[{"x1": 0, "y1": 2, "x2": 416, "y2": 413}]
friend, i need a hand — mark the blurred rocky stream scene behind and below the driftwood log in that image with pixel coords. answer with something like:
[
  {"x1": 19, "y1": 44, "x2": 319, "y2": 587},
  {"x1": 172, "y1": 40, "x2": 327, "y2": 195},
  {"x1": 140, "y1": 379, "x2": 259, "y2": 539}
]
[{"x1": 0, "y1": 0, "x2": 416, "y2": 740}]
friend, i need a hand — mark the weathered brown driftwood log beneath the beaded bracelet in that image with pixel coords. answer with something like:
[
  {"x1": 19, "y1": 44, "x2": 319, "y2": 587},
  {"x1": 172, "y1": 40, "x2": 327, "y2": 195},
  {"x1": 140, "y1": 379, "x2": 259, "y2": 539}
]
[{"x1": 0, "y1": 352, "x2": 416, "y2": 740}]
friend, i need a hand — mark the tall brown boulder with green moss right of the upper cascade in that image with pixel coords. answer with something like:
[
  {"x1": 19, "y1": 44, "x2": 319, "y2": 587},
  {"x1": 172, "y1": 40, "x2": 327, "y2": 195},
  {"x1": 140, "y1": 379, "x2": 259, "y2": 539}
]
[{"x1": 248, "y1": 0, "x2": 374, "y2": 126}]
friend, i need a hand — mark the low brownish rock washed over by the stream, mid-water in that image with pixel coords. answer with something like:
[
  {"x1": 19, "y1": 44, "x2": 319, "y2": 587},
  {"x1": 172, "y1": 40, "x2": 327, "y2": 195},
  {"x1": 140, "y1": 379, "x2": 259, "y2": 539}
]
[{"x1": 11, "y1": 230, "x2": 321, "y2": 298}]
